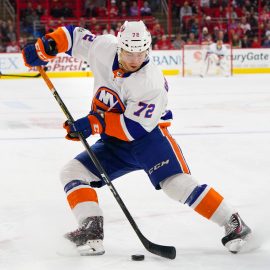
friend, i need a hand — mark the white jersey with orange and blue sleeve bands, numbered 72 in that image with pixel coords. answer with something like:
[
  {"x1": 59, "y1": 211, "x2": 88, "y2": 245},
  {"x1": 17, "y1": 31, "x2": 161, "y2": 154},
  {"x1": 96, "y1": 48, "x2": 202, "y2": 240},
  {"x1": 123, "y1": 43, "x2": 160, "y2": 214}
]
[{"x1": 46, "y1": 26, "x2": 168, "y2": 141}]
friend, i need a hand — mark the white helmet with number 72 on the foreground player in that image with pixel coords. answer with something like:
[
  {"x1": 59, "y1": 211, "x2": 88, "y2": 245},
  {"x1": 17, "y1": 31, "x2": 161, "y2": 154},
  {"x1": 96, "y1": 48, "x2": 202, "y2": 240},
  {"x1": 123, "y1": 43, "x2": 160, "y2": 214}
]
[{"x1": 117, "y1": 21, "x2": 152, "y2": 52}]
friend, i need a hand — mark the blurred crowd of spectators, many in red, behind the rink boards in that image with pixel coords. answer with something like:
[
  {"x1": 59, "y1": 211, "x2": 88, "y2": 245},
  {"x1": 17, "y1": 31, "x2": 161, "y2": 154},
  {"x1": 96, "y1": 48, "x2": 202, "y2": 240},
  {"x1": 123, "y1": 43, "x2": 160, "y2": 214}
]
[{"x1": 0, "y1": 0, "x2": 270, "y2": 52}]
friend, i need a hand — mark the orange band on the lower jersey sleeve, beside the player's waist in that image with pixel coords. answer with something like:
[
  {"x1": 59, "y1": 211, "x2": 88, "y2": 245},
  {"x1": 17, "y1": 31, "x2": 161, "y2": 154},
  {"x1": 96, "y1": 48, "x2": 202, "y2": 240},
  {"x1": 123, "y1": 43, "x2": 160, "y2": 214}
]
[{"x1": 105, "y1": 112, "x2": 129, "y2": 141}]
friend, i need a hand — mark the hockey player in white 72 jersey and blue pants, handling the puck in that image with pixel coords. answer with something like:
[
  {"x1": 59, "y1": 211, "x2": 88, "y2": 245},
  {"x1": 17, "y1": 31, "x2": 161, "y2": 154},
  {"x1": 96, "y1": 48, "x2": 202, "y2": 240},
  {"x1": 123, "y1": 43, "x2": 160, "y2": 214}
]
[{"x1": 23, "y1": 21, "x2": 251, "y2": 255}]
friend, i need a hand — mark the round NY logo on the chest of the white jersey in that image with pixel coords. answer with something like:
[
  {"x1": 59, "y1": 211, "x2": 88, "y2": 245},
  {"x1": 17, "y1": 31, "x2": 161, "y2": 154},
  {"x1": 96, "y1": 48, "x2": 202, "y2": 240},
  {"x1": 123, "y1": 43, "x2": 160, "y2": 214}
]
[{"x1": 92, "y1": 86, "x2": 125, "y2": 113}]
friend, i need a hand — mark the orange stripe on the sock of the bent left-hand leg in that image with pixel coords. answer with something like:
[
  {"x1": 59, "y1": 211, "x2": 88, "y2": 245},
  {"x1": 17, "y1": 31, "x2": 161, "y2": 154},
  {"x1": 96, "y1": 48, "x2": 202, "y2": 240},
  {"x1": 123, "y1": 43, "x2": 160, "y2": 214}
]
[{"x1": 67, "y1": 188, "x2": 98, "y2": 209}]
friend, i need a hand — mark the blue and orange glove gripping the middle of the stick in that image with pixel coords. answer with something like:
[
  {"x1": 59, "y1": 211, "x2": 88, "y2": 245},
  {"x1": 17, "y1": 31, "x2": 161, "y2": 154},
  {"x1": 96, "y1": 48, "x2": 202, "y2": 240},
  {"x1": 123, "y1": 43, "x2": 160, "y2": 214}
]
[{"x1": 63, "y1": 112, "x2": 105, "y2": 141}]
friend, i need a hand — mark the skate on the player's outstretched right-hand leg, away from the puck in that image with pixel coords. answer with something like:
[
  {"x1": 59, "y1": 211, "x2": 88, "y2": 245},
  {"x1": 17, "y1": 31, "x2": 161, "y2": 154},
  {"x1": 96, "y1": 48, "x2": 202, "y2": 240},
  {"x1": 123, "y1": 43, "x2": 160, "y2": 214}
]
[{"x1": 221, "y1": 213, "x2": 251, "y2": 253}]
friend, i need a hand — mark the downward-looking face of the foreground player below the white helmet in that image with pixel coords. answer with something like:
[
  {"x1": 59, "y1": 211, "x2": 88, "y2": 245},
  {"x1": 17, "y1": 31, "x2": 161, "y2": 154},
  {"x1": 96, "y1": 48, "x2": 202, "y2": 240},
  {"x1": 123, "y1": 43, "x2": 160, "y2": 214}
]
[{"x1": 120, "y1": 50, "x2": 147, "y2": 72}]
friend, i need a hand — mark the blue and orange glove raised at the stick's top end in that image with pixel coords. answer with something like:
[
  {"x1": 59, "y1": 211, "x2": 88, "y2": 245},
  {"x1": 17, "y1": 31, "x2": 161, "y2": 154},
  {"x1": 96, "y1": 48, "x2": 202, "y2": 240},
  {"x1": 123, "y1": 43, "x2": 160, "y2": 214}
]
[{"x1": 22, "y1": 36, "x2": 57, "y2": 67}]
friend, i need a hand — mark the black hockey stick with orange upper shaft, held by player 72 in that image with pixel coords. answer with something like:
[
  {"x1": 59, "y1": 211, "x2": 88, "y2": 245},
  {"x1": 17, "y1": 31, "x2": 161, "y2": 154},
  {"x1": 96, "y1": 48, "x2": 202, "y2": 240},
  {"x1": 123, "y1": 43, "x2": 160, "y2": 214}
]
[{"x1": 38, "y1": 67, "x2": 176, "y2": 259}]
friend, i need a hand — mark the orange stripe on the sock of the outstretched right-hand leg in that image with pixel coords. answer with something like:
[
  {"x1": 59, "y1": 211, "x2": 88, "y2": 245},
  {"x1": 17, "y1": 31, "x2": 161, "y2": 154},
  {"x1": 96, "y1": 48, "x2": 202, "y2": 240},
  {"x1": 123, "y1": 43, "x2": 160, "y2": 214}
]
[{"x1": 194, "y1": 188, "x2": 223, "y2": 219}]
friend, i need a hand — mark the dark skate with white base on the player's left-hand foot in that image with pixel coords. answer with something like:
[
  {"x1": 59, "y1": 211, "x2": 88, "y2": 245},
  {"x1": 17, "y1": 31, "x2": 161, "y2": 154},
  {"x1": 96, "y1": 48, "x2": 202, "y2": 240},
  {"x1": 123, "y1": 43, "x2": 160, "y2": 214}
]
[{"x1": 65, "y1": 216, "x2": 105, "y2": 256}]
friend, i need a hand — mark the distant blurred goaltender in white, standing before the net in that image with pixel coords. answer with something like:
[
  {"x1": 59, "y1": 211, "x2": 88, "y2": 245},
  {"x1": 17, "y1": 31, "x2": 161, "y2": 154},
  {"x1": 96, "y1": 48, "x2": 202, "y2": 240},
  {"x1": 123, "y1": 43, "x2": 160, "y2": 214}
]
[{"x1": 200, "y1": 40, "x2": 230, "y2": 77}]
